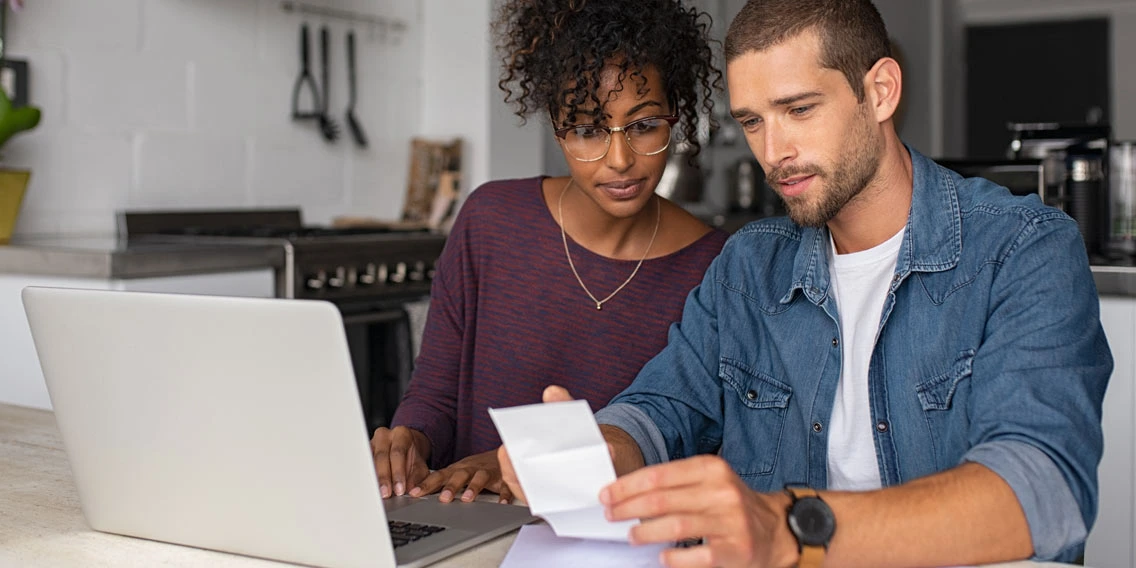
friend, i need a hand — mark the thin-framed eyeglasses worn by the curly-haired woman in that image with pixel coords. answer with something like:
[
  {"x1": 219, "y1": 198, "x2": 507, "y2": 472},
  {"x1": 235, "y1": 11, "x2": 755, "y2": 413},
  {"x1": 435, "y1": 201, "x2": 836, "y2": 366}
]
[{"x1": 556, "y1": 116, "x2": 678, "y2": 161}]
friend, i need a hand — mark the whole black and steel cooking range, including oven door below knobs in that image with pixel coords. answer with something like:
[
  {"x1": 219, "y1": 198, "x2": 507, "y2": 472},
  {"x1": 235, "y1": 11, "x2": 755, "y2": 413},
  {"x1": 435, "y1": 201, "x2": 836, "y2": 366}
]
[{"x1": 119, "y1": 209, "x2": 445, "y2": 429}]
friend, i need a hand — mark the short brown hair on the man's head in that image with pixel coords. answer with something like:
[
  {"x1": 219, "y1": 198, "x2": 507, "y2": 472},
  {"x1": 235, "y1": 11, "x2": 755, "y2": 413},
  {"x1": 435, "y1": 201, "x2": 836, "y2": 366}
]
[{"x1": 726, "y1": 0, "x2": 892, "y2": 101}]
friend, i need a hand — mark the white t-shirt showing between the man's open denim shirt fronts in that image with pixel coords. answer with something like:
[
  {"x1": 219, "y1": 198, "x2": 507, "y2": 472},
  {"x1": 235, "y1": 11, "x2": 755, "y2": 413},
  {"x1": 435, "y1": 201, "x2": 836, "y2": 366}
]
[{"x1": 828, "y1": 229, "x2": 903, "y2": 491}]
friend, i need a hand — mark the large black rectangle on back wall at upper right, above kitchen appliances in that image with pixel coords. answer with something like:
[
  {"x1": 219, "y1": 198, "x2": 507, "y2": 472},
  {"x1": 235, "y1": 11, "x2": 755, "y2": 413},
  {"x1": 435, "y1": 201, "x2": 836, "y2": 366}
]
[{"x1": 967, "y1": 18, "x2": 1112, "y2": 158}]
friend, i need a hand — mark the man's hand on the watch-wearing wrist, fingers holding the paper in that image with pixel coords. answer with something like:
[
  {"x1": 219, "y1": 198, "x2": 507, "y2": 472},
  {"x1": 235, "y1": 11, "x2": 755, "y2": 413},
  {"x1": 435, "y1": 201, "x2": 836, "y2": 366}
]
[{"x1": 600, "y1": 456, "x2": 799, "y2": 568}]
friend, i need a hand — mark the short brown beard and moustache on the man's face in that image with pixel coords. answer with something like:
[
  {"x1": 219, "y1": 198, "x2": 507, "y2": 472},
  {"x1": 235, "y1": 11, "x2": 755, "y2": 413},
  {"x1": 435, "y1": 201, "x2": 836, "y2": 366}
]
[{"x1": 768, "y1": 103, "x2": 882, "y2": 228}]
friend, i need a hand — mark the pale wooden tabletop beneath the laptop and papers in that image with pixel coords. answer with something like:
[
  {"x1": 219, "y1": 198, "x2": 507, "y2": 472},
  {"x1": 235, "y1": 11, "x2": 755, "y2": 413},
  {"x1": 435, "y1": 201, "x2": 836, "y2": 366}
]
[{"x1": 0, "y1": 404, "x2": 1090, "y2": 568}]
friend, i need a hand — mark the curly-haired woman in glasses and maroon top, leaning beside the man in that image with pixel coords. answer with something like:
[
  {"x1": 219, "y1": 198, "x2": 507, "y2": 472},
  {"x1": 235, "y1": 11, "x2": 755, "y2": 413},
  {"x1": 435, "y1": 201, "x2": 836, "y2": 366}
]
[{"x1": 371, "y1": 0, "x2": 726, "y2": 502}]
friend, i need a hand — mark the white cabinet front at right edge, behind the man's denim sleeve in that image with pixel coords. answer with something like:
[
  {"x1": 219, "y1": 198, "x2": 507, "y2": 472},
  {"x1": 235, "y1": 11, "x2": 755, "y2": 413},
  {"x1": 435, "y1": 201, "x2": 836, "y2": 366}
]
[{"x1": 1085, "y1": 296, "x2": 1136, "y2": 568}]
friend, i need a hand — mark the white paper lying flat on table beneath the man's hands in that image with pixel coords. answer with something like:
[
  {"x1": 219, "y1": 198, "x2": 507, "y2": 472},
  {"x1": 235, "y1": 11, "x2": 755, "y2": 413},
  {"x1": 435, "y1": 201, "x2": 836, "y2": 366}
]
[{"x1": 501, "y1": 525, "x2": 667, "y2": 568}]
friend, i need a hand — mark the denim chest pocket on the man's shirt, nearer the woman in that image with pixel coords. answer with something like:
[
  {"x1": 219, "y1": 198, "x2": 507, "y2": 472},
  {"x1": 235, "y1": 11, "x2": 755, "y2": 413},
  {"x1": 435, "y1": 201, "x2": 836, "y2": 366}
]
[{"x1": 719, "y1": 358, "x2": 793, "y2": 477}]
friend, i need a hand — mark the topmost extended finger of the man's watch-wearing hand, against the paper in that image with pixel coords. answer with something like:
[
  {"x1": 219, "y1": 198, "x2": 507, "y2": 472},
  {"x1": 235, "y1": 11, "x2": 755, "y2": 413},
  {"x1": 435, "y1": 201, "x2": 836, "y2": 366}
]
[{"x1": 600, "y1": 456, "x2": 734, "y2": 507}]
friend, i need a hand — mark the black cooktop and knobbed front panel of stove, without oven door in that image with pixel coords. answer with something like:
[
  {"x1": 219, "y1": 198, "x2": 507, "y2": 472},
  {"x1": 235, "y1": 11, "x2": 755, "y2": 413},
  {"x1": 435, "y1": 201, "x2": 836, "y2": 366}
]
[{"x1": 119, "y1": 209, "x2": 445, "y2": 303}]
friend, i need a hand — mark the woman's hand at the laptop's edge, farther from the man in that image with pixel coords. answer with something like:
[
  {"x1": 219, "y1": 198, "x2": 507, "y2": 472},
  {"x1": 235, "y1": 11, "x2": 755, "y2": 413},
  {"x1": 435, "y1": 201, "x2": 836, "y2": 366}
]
[{"x1": 370, "y1": 426, "x2": 429, "y2": 499}]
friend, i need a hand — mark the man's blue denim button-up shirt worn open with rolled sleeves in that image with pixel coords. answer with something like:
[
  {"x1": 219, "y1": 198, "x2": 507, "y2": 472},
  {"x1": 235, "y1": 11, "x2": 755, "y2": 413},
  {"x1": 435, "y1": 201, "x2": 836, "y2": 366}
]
[{"x1": 596, "y1": 148, "x2": 1112, "y2": 561}]
